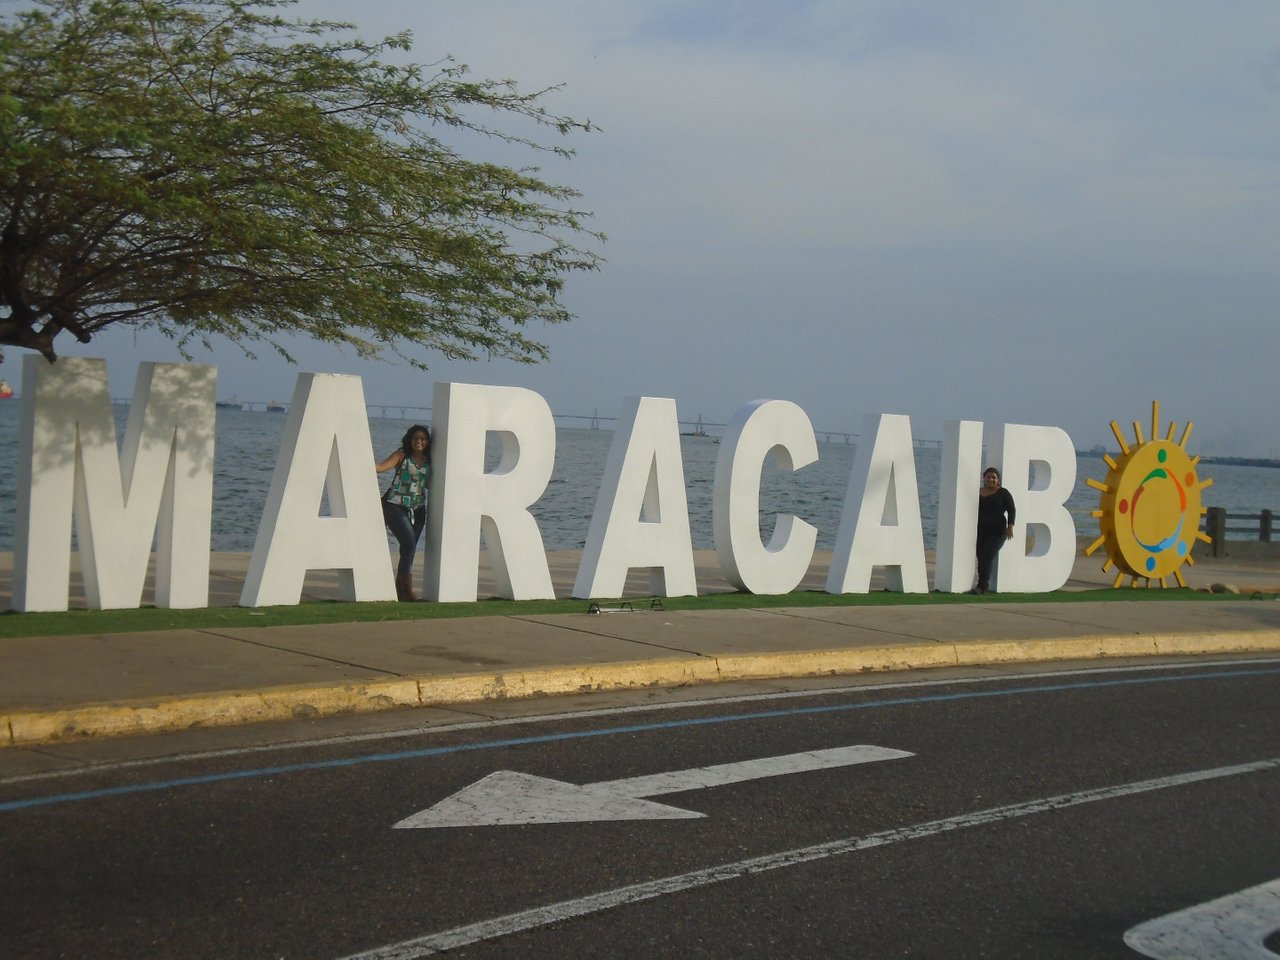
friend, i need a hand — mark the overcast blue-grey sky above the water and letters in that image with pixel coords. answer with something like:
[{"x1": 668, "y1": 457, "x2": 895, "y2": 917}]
[{"x1": 24, "y1": 0, "x2": 1280, "y2": 457}]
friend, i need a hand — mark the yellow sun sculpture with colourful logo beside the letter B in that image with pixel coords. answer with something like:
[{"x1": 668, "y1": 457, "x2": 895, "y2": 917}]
[{"x1": 1084, "y1": 402, "x2": 1213, "y2": 588}]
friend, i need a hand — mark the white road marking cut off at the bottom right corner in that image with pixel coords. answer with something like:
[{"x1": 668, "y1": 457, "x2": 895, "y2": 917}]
[{"x1": 1124, "y1": 879, "x2": 1280, "y2": 960}]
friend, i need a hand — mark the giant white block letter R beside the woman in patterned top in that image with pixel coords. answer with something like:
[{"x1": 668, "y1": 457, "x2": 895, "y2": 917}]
[{"x1": 424, "y1": 383, "x2": 556, "y2": 602}]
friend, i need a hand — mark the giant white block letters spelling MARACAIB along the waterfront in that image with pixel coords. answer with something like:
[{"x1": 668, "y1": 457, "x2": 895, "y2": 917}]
[{"x1": 13, "y1": 356, "x2": 1076, "y2": 611}]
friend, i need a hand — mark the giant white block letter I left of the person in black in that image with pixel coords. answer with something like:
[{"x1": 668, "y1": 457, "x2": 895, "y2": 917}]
[{"x1": 933, "y1": 420, "x2": 983, "y2": 594}]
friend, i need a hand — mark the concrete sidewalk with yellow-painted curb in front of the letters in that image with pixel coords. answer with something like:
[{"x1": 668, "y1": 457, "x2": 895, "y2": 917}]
[{"x1": 0, "y1": 552, "x2": 1280, "y2": 746}]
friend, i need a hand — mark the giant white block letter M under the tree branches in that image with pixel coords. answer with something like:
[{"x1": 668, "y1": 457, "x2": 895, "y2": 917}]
[{"x1": 13, "y1": 356, "x2": 216, "y2": 611}]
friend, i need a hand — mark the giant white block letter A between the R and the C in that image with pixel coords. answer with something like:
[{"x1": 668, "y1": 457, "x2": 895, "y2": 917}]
[{"x1": 573, "y1": 397, "x2": 698, "y2": 598}]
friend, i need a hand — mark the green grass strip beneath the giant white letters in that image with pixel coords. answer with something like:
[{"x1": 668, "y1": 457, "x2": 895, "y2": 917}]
[{"x1": 0, "y1": 589, "x2": 1277, "y2": 639}]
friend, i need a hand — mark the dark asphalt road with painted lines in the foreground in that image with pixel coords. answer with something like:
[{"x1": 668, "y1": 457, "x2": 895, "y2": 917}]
[{"x1": 0, "y1": 658, "x2": 1280, "y2": 960}]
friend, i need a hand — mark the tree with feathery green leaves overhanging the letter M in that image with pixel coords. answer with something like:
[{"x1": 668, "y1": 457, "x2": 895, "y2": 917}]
[{"x1": 0, "y1": 0, "x2": 603, "y2": 367}]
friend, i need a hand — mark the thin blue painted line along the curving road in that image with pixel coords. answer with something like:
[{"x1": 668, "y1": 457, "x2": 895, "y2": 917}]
[{"x1": 0, "y1": 668, "x2": 1280, "y2": 813}]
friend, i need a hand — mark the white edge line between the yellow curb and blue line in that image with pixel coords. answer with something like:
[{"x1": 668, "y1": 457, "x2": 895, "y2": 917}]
[{"x1": 10, "y1": 657, "x2": 1280, "y2": 786}]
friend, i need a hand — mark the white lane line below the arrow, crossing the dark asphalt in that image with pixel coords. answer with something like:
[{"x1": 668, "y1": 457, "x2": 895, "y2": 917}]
[{"x1": 344, "y1": 758, "x2": 1280, "y2": 960}]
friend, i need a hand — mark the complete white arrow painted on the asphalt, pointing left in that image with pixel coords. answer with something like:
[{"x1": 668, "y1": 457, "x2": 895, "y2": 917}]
[{"x1": 396, "y1": 745, "x2": 911, "y2": 828}]
